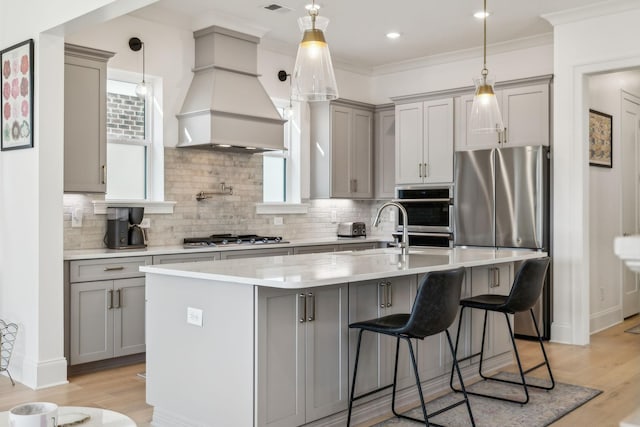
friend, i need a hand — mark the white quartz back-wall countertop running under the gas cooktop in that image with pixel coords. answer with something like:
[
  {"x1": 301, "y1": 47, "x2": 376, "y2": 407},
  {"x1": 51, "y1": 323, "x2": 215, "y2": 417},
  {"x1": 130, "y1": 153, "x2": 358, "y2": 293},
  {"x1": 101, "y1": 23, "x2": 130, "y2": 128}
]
[{"x1": 64, "y1": 236, "x2": 384, "y2": 261}]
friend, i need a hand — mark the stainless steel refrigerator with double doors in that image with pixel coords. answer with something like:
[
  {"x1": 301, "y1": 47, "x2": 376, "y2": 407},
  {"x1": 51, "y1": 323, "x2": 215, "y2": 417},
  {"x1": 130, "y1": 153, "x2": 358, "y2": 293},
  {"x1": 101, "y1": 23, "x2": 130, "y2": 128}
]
[{"x1": 453, "y1": 146, "x2": 551, "y2": 339}]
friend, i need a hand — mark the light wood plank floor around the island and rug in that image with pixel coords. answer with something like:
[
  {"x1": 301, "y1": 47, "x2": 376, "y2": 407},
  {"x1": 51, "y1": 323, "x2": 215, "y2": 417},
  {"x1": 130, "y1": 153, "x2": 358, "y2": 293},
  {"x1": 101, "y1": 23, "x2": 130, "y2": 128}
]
[{"x1": 0, "y1": 316, "x2": 640, "y2": 427}]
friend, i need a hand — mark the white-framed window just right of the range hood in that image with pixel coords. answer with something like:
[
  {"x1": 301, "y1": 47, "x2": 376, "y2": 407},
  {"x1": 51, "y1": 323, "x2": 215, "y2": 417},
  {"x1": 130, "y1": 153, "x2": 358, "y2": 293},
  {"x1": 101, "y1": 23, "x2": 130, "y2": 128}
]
[{"x1": 263, "y1": 100, "x2": 301, "y2": 204}]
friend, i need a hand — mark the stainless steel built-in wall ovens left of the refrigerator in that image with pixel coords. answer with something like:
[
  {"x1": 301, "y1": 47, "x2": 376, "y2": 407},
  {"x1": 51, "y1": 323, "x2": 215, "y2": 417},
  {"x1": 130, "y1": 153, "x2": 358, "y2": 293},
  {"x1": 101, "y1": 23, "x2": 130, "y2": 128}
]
[{"x1": 393, "y1": 185, "x2": 454, "y2": 247}]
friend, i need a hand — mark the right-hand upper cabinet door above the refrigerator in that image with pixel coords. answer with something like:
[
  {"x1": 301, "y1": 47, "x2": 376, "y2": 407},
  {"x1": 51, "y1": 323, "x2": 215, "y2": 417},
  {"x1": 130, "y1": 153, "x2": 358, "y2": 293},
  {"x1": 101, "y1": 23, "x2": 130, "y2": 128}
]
[{"x1": 502, "y1": 84, "x2": 549, "y2": 147}]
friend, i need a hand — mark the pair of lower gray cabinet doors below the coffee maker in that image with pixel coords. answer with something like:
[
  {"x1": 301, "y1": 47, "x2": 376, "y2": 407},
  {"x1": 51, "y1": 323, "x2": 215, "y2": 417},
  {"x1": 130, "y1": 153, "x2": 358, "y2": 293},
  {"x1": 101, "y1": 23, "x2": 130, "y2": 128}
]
[{"x1": 70, "y1": 277, "x2": 145, "y2": 365}]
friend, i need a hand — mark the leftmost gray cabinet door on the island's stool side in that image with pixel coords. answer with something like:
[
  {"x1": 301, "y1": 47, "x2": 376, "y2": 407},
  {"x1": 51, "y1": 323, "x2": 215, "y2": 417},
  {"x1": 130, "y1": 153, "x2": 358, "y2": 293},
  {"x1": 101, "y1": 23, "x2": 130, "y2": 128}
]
[{"x1": 257, "y1": 287, "x2": 306, "y2": 427}]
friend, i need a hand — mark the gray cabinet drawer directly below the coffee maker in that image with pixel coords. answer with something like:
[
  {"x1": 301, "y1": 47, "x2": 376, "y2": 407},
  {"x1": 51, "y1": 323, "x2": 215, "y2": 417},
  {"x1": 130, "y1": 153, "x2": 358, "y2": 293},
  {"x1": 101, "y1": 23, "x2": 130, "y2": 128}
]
[{"x1": 69, "y1": 256, "x2": 152, "y2": 283}]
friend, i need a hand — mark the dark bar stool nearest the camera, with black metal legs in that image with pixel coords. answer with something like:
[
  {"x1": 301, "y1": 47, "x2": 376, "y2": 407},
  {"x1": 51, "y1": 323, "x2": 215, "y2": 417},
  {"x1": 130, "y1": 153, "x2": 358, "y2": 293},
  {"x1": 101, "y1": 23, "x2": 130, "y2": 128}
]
[{"x1": 347, "y1": 267, "x2": 475, "y2": 426}]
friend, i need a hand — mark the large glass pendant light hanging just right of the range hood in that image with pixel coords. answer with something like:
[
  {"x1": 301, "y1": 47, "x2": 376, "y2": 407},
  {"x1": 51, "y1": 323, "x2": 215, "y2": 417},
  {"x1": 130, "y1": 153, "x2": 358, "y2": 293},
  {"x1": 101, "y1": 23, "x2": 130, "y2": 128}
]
[{"x1": 291, "y1": 0, "x2": 338, "y2": 101}]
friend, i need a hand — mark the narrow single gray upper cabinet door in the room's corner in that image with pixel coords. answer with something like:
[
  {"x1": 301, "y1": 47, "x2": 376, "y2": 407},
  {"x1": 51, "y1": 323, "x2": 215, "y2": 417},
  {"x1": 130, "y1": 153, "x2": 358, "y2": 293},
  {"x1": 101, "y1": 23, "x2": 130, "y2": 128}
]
[{"x1": 373, "y1": 105, "x2": 396, "y2": 200}]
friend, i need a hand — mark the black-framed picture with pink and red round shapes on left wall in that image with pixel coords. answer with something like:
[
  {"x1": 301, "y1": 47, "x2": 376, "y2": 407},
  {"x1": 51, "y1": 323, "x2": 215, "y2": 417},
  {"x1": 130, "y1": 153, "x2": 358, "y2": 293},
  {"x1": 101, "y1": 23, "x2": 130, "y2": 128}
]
[{"x1": 0, "y1": 39, "x2": 33, "y2": 151}]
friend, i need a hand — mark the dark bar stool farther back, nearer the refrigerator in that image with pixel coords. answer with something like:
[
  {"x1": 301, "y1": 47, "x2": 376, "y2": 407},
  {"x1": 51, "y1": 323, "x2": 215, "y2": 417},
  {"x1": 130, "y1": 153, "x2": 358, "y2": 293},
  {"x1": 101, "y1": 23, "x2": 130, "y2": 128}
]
[{"x1": 449, "y1": 257, "x2": 555, "y2": 405}]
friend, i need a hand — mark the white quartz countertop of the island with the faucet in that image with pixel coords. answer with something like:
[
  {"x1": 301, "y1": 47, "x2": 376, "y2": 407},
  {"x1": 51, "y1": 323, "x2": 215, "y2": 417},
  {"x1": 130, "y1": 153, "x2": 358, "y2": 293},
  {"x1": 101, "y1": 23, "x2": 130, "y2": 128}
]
[{"x1": 140, "y1": 248, "x2": 546, "y2": 289}]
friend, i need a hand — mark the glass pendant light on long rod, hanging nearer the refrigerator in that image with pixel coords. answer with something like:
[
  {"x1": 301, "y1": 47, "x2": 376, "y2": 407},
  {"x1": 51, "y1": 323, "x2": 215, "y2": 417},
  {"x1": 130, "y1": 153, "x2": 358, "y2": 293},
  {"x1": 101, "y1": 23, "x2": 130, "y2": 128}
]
[{"x1": 469, "y1": 0, "x2": 504, "y2": 133}]
